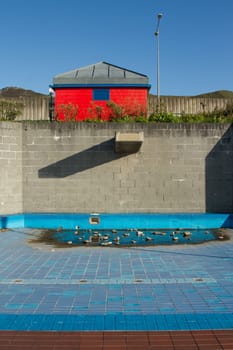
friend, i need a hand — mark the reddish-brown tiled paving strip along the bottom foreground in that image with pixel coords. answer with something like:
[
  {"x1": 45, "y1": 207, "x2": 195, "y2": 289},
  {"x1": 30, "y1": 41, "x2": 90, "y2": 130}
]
[{"x1": 0, "y1": 330, "x2": 233, "y2": 350}]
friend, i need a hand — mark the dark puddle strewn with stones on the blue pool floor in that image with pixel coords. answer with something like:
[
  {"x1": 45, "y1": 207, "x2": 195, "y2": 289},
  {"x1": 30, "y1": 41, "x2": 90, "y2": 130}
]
[{"x1": 30, "y1": 227, "x2": 229, "y2": 248}]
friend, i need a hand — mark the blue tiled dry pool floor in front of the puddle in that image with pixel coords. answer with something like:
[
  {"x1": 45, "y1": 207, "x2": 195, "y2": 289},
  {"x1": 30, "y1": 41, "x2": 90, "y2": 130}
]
[{"x1": 0, "y1": 228, "x2": 233, "y2": 331}]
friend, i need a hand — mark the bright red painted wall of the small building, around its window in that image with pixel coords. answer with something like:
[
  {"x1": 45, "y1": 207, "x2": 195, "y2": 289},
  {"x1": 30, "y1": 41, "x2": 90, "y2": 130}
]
[{"x1": 55, "y1": 87, "x2": 148, "y2": 121}]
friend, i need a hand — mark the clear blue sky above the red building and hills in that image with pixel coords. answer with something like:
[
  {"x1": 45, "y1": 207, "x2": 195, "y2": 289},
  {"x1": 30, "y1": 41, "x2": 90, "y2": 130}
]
[{"x1": 0, "y1": 0, "x2": 233, "y2": 95}]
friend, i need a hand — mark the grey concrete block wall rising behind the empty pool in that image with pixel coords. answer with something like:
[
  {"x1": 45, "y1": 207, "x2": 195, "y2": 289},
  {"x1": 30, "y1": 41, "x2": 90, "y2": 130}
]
[{"x1": 0, "y1": 122, "x2": 233, "y2": 214}]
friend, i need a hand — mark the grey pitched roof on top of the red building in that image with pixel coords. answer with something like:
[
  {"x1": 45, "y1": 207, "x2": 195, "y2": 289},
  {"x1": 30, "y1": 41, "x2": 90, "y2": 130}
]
[{"x1": 53, "y1": 62, "x2": 149, "y2": 85}]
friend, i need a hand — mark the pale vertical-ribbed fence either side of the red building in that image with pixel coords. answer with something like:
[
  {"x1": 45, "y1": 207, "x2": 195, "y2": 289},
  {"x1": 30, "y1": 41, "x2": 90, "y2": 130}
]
[{"x1": 0, "y1": 95, "x2": 233, "y2": 121}]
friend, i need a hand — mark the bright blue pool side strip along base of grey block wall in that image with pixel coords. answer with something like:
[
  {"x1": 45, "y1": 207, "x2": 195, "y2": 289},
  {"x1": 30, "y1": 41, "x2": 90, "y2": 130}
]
[{"x1": 0, "y1": 213, "x2": 233, "y2": 230}]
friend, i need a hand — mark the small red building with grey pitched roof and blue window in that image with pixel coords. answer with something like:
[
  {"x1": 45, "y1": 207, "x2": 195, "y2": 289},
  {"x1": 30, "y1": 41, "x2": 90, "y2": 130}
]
[{"x1": 51, "y1": 62, "x2": 150, "y2": 120}]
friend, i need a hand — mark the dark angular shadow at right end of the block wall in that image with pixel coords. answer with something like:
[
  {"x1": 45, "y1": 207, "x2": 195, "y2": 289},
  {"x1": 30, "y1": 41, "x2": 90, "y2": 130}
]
[{"x1": 205, "y1": 126, "x2": 233, "y2": 213}]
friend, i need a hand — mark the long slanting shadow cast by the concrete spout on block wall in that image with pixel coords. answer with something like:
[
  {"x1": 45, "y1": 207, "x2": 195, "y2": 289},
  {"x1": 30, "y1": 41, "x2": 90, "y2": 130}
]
[{"x1": 38, "y1": 138, "x2": 128, "y2": 178}]
